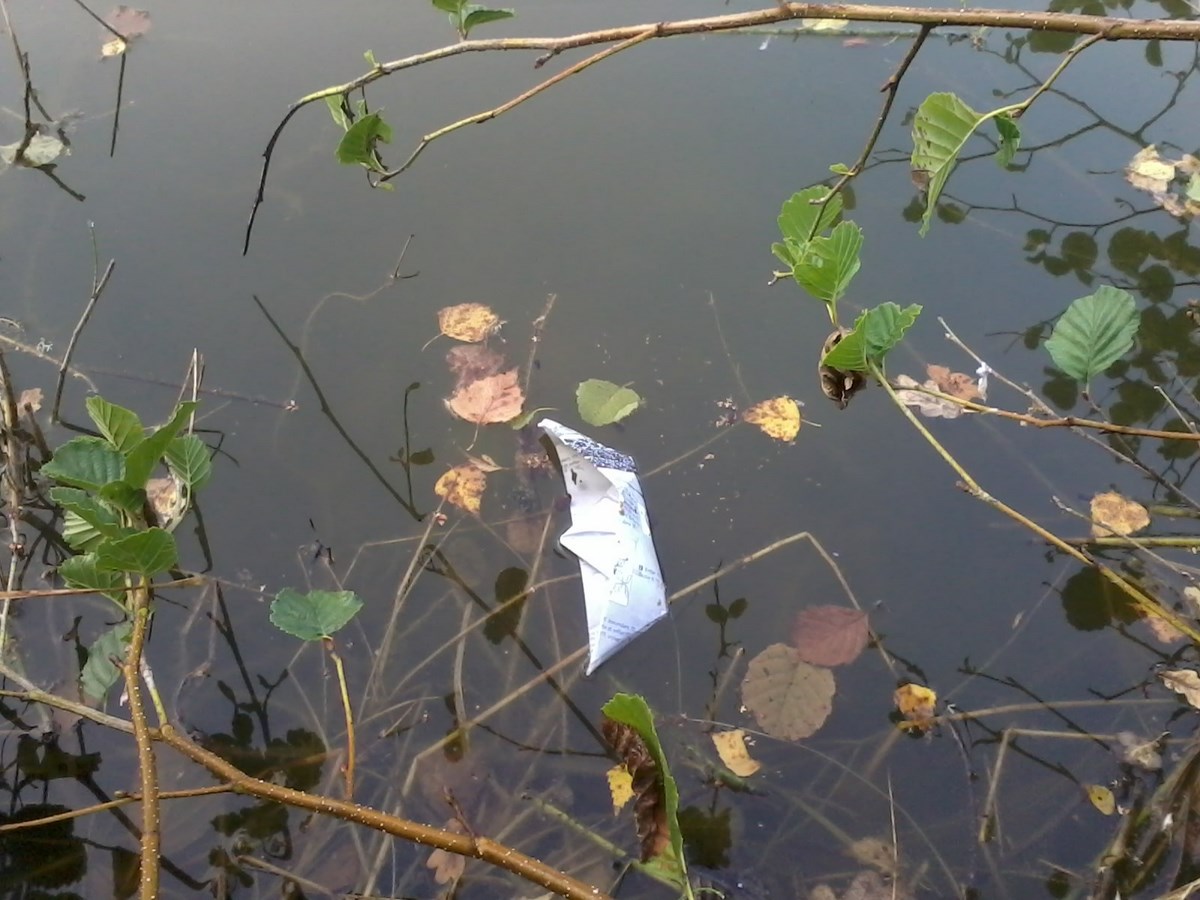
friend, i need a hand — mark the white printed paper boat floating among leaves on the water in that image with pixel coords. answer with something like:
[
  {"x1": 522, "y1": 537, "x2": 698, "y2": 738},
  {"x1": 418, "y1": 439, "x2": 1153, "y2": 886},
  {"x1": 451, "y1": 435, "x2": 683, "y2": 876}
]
[{"x1": 538, "y1": 419, "x2": 667, "y2": 674}]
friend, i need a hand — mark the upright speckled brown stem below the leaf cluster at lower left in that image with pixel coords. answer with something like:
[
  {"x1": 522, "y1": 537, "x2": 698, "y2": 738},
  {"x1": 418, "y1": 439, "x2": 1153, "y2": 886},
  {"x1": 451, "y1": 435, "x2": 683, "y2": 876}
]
[{"x1": 121, "y1": 578, "x2": 166, "y2": 900}]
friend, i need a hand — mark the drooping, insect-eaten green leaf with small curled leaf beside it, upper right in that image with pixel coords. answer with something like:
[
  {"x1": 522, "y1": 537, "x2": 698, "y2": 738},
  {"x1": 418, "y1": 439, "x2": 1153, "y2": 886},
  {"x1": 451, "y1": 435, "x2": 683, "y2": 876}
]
[{"x1": 912, "y1": 92, "x2": 1021, "y2": 238}]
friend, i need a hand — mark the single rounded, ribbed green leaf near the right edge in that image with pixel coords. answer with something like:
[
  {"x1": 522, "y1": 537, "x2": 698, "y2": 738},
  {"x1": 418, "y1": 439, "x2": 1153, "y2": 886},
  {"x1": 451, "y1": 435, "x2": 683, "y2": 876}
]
[{"x1": 1045, "y1": 284, "x2": 1138, "y2": 386}]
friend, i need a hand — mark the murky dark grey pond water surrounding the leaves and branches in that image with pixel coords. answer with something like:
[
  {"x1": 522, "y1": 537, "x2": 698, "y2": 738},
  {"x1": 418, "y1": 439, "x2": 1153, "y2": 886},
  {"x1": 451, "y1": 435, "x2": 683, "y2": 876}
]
[{"x1": 0, "y1": 2, "x2": 1200, "y2": 896}]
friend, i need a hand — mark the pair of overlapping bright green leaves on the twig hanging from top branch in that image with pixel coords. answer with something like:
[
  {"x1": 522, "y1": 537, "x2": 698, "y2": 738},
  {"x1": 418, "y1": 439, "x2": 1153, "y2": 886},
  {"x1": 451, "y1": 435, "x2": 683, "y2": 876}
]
[{"x1": 770, "y1": 185, "x2": 863, "y2": 325}]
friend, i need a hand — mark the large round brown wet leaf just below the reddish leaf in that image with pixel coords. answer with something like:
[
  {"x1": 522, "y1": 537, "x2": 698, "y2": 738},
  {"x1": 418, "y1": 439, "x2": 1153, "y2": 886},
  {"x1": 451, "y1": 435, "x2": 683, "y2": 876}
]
[{"x1": 742, "y1": 643, "x2": 836, "y2": 740}]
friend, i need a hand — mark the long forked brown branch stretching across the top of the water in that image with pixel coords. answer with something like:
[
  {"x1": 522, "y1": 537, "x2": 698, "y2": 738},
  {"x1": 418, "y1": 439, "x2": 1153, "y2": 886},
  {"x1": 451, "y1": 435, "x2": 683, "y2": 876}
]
[{"x1": 242, "y1": 2, "x2": 1200, "y2": 254}]
